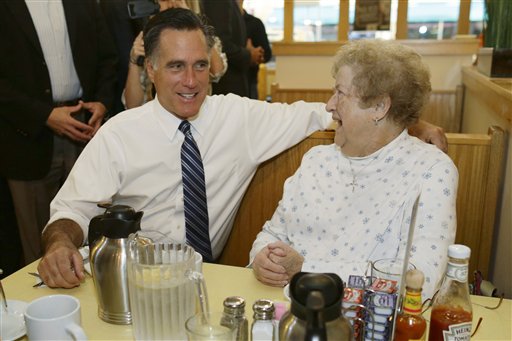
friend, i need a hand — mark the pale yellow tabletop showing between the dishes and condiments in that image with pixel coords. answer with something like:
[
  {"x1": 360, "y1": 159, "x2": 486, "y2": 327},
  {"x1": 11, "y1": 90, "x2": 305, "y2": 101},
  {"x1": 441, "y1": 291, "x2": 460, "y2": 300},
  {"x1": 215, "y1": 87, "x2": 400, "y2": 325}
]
[{"x1": 2, "y1": 261, "x2": 512, "y2": 340}]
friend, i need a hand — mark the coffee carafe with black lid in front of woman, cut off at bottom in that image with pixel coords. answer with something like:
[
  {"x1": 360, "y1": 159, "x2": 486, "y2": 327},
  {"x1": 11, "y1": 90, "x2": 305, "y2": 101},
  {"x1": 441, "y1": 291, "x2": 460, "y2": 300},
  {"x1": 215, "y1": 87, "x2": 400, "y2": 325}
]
[{"x1": 279, "y1": 272, "x2": 354, "y2": 341}]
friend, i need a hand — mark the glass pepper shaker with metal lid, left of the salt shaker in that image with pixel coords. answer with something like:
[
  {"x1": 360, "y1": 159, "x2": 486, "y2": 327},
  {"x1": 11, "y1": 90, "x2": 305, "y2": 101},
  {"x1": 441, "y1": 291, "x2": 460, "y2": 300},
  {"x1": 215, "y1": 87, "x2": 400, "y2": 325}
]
[{"x1": 221, "y1": 296, "x2": 249, "y2": 341}]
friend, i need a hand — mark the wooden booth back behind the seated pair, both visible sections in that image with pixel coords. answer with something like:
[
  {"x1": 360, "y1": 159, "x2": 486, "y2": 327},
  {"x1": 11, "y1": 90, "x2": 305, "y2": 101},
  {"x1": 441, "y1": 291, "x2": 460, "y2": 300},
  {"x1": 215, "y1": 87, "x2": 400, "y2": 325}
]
[{"x1": 220, "y1": 127, "x2": 504, "y2": 278}]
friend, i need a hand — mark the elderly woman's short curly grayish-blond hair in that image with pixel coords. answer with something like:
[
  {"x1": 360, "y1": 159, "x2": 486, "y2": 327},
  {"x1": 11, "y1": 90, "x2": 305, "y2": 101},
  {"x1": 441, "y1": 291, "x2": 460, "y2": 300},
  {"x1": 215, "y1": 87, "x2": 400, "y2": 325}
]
[{"x1": 331, "y1": 39, "x2": 431, "y2": 127}]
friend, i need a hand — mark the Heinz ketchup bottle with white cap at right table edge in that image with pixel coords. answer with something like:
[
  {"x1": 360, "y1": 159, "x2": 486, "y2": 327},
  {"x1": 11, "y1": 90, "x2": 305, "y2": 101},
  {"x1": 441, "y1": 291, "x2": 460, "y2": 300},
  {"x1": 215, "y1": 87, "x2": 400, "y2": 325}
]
[{"x1": 428, "y1": 244, "x2": 473, "y2": 341}]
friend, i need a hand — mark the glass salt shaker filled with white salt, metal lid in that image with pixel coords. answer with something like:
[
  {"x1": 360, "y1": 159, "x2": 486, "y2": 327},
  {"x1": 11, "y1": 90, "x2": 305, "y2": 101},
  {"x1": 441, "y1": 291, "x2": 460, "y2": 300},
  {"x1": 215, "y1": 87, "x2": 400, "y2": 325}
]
[{"x1": 251, "y1": 299, "x2": 277, "y2": 341}]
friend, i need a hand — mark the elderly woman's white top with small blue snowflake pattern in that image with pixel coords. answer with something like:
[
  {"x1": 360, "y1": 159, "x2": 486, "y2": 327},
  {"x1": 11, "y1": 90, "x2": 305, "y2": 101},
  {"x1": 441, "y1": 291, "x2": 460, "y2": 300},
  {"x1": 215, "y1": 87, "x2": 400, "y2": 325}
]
[{"x1": 250, "y1": 130, "x2": 458, "y2": 297}]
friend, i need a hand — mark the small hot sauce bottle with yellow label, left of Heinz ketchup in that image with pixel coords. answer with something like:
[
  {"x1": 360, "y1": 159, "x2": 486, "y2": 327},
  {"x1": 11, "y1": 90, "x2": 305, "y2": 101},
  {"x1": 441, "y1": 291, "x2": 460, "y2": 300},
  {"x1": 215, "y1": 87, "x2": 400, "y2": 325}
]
[{"x1": 394, "y1": 269, "x2": 427, "y2": 341}]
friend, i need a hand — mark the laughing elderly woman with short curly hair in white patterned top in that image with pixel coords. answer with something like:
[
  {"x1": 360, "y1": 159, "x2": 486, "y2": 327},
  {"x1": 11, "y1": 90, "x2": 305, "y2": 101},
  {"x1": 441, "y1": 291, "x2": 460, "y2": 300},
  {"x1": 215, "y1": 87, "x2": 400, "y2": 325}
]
[{"x1": 250, "y1": 40, "x2": 458, "y2": 295}]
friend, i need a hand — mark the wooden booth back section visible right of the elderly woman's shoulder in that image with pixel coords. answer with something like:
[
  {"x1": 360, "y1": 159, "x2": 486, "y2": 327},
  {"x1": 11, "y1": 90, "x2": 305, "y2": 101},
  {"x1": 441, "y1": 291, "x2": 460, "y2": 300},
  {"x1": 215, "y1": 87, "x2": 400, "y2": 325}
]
[{"x1": 446, "y1": 127, "x2": 505, "y2": 278}]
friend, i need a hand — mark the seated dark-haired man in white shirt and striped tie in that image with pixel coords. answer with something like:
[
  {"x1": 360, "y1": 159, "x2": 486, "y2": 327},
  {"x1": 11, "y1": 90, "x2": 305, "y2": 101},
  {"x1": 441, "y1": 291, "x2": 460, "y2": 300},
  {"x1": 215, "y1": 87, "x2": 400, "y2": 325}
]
[{"x1": 38, "y1": 8, "x2": 448, "y2": 288}]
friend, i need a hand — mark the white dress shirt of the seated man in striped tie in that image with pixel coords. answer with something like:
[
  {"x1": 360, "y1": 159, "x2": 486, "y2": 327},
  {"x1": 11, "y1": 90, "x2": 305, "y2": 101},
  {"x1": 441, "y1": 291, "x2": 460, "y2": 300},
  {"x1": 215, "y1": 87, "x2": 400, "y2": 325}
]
[{"x1": 49, "y1": 94, "x2": 332, "y2": 258}]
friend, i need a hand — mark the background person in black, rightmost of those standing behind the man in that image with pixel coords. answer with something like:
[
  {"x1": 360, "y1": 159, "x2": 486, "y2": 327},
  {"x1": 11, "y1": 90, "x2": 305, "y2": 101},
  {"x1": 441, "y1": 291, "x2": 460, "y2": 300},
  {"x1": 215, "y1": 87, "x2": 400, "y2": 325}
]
[{"x1": 237, "y1": 0, "x2": 272, "y2": 99}]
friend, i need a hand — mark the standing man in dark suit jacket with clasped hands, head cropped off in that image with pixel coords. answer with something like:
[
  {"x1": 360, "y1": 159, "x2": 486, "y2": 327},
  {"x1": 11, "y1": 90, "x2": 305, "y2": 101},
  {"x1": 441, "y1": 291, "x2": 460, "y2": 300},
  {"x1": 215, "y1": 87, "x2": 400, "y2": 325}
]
[{"x1": 0, "y1": 0, "x2": 117, "y2": 262}]
